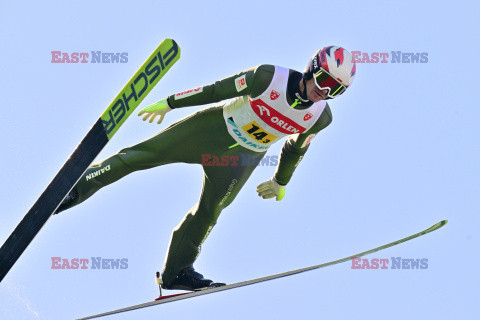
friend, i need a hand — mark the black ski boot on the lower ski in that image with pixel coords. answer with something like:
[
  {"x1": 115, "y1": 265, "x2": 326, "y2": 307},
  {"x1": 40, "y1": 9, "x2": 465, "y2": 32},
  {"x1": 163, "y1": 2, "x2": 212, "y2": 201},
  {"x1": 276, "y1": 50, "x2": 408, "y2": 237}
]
[{"x1": 160, "y1": 266, "x2": 225, "y2": 291}]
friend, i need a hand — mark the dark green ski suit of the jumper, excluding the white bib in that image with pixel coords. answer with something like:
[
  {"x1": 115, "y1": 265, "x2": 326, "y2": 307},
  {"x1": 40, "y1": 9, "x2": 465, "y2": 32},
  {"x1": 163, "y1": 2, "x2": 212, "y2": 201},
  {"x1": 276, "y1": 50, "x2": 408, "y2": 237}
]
[{"x1": 64, "y1": 65, "x2": 332, "y2": 284}]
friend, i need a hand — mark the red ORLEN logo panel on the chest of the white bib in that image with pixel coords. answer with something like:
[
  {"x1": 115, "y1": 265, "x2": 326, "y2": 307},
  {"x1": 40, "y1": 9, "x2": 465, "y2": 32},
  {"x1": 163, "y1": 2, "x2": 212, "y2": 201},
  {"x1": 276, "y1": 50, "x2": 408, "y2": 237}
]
[{"x1": 250, "y1": 99, "x2": 305, "y2": 134}]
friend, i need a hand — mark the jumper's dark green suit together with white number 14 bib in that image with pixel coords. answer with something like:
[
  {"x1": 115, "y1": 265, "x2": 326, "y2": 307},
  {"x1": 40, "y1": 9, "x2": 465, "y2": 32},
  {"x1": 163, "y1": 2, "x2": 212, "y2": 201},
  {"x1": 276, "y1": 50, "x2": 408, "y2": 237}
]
[{"x1": 64, "y1": 65, "x2": 332, "y2": 284}]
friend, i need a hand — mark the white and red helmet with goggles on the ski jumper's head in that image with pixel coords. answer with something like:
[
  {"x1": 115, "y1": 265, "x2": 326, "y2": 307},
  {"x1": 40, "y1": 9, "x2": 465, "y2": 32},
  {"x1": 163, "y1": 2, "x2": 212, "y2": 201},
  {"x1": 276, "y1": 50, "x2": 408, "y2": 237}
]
[{"x1": 303, "y1": 46, "x2": 357, "y2": 99}]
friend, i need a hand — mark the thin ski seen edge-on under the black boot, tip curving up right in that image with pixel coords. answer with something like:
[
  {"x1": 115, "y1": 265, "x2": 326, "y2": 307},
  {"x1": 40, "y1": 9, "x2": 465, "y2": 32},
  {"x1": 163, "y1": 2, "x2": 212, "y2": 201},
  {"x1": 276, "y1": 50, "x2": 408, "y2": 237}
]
[{"x1": 77, "y1": 220, "x2": 447, "y2": 320}]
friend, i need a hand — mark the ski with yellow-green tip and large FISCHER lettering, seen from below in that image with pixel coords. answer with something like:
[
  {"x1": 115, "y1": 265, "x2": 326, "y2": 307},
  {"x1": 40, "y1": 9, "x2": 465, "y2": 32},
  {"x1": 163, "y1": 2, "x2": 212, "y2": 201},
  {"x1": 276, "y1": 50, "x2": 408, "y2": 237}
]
[{"x1": 0, "y1": 39, "x2": 180, "y2": 282}]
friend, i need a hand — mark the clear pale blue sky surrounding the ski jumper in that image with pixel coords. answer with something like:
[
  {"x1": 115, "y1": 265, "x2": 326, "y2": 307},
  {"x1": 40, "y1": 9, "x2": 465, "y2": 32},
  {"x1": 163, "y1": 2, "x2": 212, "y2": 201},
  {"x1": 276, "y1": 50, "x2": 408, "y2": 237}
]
[{"x1": 0, "y1": 0, "x2": 480, "y2": 320}]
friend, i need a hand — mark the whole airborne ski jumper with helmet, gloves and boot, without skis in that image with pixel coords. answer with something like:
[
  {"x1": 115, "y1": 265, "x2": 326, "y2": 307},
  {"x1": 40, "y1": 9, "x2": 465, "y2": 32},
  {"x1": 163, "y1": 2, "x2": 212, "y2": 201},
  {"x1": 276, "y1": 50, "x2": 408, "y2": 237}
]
[{"x1": 56, "y1": 46, "x2": 356, "y2": 291}]
